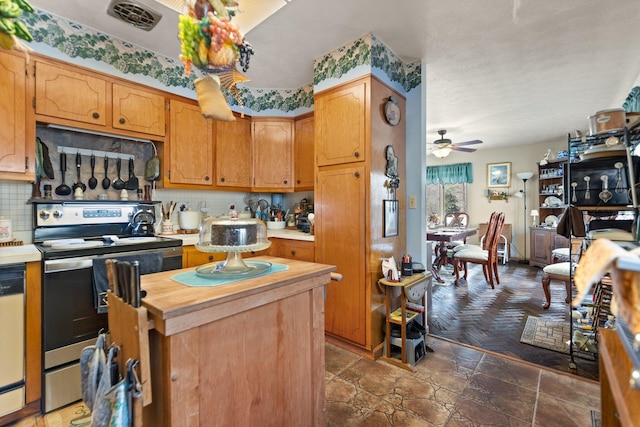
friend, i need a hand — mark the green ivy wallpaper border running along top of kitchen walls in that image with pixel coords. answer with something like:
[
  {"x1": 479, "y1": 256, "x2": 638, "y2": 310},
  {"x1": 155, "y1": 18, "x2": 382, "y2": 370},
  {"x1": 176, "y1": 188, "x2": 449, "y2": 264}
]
[{"x1": 22, "y1": 9, "x2": 421, "y2": 114}]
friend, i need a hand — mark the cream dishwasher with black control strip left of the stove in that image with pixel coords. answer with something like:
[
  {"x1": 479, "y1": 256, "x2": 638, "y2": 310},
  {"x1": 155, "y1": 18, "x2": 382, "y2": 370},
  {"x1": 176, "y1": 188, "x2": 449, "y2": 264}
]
[{"x1": 0, "y1": 263, "x2": 25, "y2": 417}]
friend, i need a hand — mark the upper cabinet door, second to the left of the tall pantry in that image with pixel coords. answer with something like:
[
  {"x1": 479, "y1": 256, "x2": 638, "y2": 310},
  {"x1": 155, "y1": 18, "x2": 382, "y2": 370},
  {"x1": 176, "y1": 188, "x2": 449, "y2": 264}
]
[{"x1": 252, "y1": 120, "x2": 293, "y2": 190}]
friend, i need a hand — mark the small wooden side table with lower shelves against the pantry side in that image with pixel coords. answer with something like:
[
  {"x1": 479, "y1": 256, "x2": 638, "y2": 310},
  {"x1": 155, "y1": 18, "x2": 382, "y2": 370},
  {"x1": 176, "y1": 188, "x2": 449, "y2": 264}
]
[{"x1": 378, "y1": 273, "x2": 431, "y2": 372}]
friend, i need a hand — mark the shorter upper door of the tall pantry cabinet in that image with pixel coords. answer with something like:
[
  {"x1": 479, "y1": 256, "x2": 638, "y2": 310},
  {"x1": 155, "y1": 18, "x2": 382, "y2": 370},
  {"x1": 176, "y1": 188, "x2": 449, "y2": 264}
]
[{"x1": 314, "y1": 79, "x2": 371, "y2": 166}]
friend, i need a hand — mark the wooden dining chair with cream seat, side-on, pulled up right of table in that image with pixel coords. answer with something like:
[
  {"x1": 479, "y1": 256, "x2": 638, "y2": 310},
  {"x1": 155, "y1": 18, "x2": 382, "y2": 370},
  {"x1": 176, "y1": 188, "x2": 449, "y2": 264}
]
[{"x1": 453, "y1": 212, "x2": 505, "y2": 289}]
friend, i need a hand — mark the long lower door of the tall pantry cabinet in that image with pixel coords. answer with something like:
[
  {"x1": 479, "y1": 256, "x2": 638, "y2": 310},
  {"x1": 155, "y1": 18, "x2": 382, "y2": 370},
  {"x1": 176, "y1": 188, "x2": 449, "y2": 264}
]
[{"x1": 315, "y1": 166, "x2": 369, "y2": 345}]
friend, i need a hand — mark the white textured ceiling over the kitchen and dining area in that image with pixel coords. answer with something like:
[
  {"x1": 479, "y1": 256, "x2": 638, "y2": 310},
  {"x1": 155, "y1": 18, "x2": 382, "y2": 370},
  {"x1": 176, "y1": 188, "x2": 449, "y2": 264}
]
[{"x1": 27, "y1": 0, "x2": 640, "y2": 149}]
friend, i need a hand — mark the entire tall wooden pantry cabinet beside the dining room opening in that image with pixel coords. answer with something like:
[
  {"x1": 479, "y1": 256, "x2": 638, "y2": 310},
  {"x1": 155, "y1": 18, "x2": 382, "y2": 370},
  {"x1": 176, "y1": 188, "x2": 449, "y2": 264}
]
[{"x1": 314, "y1": 75, "x2": 406, "y2": 357}]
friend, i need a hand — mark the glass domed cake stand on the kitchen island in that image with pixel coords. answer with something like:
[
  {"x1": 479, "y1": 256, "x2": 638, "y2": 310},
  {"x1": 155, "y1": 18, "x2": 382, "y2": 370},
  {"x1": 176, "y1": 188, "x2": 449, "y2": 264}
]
[{"x1": 195, "y1": 217, "x2": 271, "y2": 278}]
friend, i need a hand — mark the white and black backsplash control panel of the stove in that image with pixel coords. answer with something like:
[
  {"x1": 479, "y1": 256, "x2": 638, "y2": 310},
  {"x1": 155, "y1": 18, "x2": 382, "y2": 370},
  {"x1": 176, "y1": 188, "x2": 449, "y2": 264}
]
[{"x1": 36, "y1": 204, "x2": 138, "y2": 227}]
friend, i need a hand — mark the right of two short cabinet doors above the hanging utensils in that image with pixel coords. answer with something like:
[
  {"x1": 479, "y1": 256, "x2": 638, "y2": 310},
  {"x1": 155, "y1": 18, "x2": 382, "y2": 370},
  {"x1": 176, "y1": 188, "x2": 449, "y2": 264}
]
[{"x1": 112, "y1": 84, "x2": 165, "y2": 136}]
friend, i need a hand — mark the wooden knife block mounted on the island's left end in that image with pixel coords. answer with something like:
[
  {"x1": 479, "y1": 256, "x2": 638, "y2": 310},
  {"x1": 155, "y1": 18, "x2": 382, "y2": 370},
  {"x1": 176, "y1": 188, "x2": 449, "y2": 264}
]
[{"x1": 107, "y1": 292, "x2": 155, "y2": 406}]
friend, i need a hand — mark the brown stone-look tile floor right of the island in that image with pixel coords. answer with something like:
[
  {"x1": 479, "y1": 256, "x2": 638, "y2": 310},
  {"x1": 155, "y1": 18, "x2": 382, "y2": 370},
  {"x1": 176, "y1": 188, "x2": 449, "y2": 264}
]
[{"x1": 325, "y1": 337, "x2": 600, "y2": 427}]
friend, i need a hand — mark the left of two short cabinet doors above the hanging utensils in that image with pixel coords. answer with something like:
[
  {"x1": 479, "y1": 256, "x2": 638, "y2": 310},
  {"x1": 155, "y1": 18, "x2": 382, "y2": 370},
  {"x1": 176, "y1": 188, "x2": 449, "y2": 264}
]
[{"x1": 36, "y1": 62, "x2": 107, "y2": 126}]
